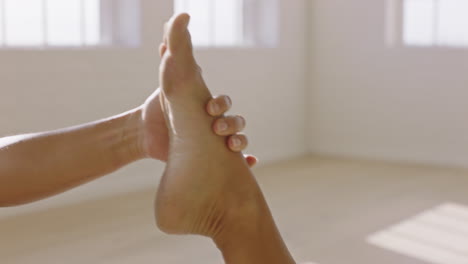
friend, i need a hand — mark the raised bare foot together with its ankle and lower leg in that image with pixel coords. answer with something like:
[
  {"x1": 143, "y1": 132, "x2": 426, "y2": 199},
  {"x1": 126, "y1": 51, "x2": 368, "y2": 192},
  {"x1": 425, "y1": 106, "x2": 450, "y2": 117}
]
[{"x1": 155, "y1": 14, "x2": 295, "y2": 264}]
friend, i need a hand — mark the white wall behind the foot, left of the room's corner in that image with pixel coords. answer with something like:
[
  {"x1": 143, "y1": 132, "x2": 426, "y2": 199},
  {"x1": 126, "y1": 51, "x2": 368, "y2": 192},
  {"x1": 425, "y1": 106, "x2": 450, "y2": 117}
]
[{"x1": 0, "y1": 0, "x2": 307, "y2": 214}]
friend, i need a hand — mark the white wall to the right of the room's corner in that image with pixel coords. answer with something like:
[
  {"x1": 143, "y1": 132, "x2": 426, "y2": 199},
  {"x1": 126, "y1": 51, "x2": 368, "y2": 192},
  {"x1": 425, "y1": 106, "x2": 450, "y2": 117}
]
[{"x1": 308, "y1": 0, "x2": 468, "y2": 167}]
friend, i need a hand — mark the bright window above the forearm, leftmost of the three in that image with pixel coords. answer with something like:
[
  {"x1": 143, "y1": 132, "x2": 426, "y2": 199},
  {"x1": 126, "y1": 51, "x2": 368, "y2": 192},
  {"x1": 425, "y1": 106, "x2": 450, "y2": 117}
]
[{"x1": 0, "y1": 0, "x2": 140, "y2": 47}]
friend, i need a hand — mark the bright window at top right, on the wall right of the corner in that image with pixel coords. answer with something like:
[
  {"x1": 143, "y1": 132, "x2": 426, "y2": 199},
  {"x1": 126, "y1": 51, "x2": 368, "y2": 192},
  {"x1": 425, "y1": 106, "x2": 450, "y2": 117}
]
[{"x1": 396, "y1": 0, "x2": 468, "y2": 47}]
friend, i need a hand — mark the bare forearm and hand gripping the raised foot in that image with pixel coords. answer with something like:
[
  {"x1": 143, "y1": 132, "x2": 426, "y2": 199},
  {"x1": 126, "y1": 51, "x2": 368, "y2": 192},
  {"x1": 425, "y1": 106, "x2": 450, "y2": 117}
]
[{"x1": 0, "y1": 63, "x2": 257, "y2": 207}]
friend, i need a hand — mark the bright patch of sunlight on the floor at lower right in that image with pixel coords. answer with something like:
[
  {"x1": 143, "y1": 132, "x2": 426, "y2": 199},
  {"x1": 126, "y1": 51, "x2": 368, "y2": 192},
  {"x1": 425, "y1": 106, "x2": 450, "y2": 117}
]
[{"x1": 368, "y1": 203, "x2": 468, "y2": 264}]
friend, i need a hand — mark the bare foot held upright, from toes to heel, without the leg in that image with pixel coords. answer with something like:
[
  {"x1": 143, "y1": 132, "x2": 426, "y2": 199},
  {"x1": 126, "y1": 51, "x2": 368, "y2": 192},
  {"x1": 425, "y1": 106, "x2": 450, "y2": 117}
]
[{"x1": 156, "y1": 14, "x2": 263, "y2": 238}]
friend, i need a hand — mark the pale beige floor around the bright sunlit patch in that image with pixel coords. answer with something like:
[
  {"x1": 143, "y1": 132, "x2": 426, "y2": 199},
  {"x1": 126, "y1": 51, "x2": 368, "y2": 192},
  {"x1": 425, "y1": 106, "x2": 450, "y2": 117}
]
[{"x1": 0, "y1": 157, "x2": 468, "y2": 264}]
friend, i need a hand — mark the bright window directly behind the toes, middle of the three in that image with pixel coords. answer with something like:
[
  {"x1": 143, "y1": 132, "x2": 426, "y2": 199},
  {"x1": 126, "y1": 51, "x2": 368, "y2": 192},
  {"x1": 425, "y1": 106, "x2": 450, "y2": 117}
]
[{"x1": 175, "y1": 0, "x2": 278, "y2": 47}]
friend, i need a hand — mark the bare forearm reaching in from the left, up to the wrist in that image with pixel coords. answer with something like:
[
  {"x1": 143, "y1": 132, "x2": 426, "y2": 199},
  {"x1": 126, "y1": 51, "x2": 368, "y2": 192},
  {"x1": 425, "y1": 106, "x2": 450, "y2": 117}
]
[{"x1": 0, "y1": 106, "x2": 143, "y2": 206}]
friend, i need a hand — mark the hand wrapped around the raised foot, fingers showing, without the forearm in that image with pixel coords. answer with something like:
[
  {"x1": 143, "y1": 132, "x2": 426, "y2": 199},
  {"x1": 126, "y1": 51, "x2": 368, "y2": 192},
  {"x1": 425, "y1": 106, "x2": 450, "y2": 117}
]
[{"x1": 142, "y1": 89, "x2": 257, "y2": 167}]
